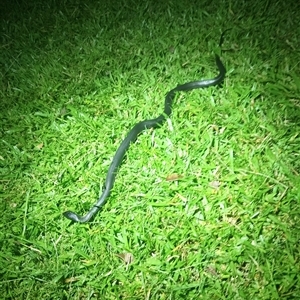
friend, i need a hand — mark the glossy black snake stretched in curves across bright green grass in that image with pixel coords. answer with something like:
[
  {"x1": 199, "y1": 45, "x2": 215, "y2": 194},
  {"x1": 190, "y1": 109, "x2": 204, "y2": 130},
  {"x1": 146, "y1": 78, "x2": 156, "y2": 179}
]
[{"x1": 63, "y1": 29, "x2": 228, "y2": 223}]
